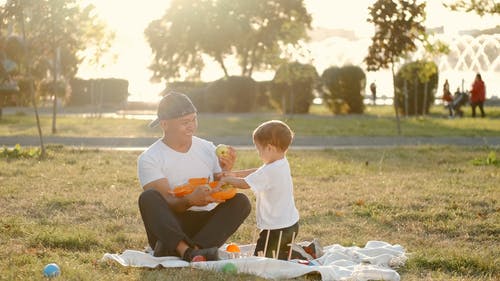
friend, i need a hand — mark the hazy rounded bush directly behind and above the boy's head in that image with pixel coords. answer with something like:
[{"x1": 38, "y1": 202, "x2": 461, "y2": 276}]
[{"x1": 271, "y1": 62, "x2": 319, "y2": 114}]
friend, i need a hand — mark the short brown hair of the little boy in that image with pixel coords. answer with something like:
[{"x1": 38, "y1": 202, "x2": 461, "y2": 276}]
[{"x1": 253, "y1": 120, "x2": 293, "y2": 151}]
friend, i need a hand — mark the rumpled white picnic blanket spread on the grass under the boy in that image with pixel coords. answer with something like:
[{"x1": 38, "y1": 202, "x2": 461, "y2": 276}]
[{"x1": 102, "y1": 241, "x2": 407, "y2": 281}]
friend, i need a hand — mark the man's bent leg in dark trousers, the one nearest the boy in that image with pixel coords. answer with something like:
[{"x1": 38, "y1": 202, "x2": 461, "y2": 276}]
[{"x1": 186, "y1": 193, "x2": 251, "y2": 248}]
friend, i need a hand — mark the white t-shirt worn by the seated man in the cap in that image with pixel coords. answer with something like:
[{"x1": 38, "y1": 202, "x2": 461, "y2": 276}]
[{"x1": 137, "y1": 137, "x2": 221, "y2": 211}]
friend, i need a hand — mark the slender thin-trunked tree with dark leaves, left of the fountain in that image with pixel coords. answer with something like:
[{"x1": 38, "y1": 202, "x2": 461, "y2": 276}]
[{"x1": 365, "y1": 0, "x2": 425, "y2": 134}]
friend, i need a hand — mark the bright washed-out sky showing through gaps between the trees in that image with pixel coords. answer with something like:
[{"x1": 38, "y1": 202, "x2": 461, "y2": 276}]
[{"x1": 79, "y1": 0, "x2": 500, "y2": 102}]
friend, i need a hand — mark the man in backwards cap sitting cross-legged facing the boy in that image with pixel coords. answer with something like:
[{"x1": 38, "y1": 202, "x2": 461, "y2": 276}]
[{"x1": 137, "y1": 92, "x2": 251, "y2": 262}]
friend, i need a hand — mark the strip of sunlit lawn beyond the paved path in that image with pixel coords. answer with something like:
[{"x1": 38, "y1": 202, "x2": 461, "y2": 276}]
[{"x1": 0, "y1": 106, "x2": 500, "y2": 138}]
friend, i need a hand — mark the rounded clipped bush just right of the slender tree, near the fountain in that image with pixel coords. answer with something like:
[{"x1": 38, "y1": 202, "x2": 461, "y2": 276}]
[{"x1": 395, "y1": 61, "x2": 438, "y2": 115}]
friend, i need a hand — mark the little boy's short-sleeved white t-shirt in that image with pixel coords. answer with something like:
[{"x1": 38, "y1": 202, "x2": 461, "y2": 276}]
[{"x1": 245, "y1": 158, "x2": 299, "y2": 229}]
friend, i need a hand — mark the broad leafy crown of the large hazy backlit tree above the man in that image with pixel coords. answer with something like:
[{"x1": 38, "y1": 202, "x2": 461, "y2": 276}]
[{"x1": 145, "y1": 0, "x2": 311, "y2": 81}]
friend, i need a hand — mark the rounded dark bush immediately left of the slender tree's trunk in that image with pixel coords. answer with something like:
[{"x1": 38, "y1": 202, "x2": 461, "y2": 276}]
[{"x1": 321, "y1": 65, "x2": 366, "y2": 114}]
